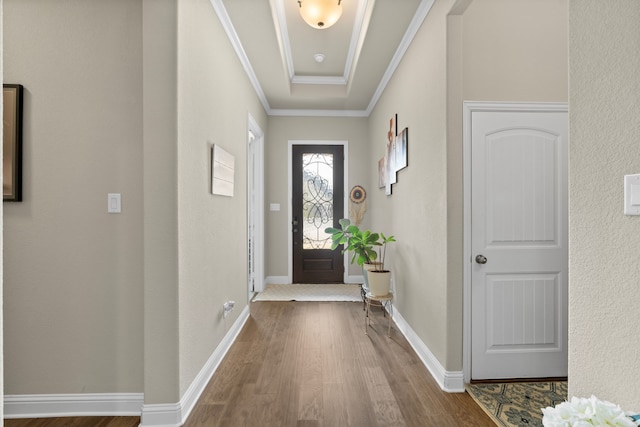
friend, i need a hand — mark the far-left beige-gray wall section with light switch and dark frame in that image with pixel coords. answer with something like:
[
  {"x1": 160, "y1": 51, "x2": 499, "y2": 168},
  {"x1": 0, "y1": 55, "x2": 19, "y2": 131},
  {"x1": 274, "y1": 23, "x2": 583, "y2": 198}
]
[{"x1": 3, "y1": 0, "x2": 143, "y2": 394}]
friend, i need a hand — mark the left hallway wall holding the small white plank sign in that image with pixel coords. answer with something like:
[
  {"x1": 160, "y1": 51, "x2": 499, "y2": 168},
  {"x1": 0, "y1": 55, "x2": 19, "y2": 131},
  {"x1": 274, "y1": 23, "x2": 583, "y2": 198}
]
[{"x1": 177, "y1": 0, "x2": 267, "y2": 395}]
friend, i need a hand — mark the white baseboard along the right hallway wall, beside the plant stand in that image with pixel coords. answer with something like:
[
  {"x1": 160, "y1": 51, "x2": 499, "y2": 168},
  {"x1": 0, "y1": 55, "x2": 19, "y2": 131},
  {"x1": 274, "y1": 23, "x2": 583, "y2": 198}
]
[{"x1": 393, "y1": 306, "x2": 464, "y2": 393}]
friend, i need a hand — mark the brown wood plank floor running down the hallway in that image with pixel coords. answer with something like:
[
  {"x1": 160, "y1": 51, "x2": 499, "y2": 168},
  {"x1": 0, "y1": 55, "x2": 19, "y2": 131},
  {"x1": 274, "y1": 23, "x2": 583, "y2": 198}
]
[{"x1": 5, "y1": 301, "x2": 495, "y2": 427}]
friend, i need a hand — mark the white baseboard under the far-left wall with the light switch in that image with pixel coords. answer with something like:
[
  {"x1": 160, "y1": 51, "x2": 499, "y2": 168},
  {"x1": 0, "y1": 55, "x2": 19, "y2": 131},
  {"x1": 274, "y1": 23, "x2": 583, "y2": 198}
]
[{"x1": 4, "y1": 393, "x2": 144, "y2": 418}]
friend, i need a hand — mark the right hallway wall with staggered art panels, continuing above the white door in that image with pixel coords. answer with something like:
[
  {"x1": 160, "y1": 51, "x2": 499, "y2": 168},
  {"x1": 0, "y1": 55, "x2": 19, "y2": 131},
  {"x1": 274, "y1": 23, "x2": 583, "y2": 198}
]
[{"x1": 368, "y1": 0, "x2": 568, "y2": 371}]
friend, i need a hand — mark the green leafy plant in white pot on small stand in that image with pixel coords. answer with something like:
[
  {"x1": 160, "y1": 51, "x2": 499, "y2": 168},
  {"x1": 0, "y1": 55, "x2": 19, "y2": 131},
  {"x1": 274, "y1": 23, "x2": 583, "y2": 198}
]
[{"x1": 325, "y1": 218, "x2": 396, "y2": 295}]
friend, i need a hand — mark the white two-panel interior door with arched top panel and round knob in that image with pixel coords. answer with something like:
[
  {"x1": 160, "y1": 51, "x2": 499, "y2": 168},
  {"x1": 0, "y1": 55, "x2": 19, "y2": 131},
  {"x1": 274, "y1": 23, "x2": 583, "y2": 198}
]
[{"x1": 471, "y1": 111, "x2": 568, "y2": 379}]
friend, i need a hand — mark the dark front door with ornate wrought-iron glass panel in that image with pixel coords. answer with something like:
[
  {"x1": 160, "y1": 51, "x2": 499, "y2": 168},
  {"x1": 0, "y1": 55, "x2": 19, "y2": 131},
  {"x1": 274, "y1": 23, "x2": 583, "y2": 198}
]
[{"x1": 291, "y1": 145, "x2": 344, "y2": 283}]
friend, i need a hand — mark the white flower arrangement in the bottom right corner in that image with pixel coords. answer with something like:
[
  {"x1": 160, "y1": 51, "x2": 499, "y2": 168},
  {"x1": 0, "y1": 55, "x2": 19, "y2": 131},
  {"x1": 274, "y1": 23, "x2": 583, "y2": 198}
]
[{"x1": 542, "y1": 396, "x2": 638, "y2": 427}]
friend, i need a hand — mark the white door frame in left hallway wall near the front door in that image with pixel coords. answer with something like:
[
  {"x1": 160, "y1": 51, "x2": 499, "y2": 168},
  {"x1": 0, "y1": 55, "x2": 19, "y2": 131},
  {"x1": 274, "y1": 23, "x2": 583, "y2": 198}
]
[{"x1": 247, "y1": 113, "x2": 265, "y2": 297}]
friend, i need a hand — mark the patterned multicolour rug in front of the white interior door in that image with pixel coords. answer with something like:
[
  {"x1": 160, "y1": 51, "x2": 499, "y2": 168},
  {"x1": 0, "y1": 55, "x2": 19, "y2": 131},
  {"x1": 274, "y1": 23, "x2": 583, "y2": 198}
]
[{"x1": 467, "y1": 381, "x2": 567, "y2": 427}]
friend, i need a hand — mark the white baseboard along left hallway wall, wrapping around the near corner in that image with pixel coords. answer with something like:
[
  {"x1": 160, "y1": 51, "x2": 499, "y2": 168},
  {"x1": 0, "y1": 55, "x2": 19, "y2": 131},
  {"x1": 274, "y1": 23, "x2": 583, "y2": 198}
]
[{"x1": 140, "y1": 305, "x2": 249, "y2": 427}]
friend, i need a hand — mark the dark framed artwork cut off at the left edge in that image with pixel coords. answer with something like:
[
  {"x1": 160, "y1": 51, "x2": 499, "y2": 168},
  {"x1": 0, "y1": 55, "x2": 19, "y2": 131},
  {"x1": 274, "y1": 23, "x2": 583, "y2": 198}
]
[{"x1": 2, "y1": 84, "x2": 23, "y2": 202}]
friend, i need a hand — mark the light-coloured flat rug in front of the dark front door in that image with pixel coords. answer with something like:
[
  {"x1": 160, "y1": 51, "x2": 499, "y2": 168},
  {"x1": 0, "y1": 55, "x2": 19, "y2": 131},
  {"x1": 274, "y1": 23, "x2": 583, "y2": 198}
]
[{"x1": 253, "y1": 284, "x2": 362, "y2": 301}]
